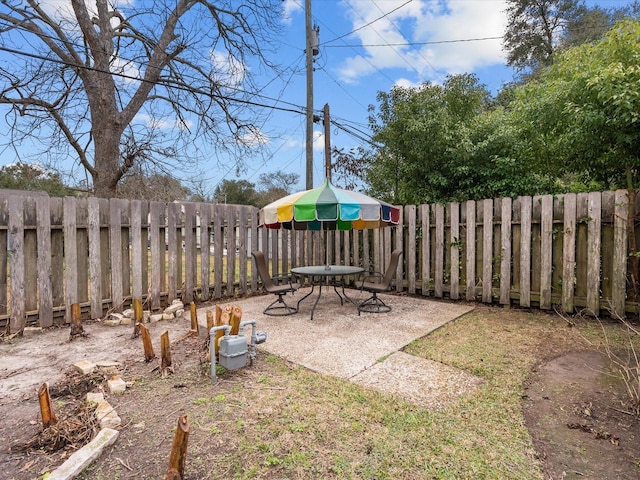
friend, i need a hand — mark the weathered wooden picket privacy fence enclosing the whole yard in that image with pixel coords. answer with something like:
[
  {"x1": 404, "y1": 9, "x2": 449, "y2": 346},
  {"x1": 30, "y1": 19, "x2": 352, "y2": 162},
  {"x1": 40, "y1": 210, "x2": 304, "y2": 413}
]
[{"x1": 0, "y1": 190, "x2": 638, "y2": 332}]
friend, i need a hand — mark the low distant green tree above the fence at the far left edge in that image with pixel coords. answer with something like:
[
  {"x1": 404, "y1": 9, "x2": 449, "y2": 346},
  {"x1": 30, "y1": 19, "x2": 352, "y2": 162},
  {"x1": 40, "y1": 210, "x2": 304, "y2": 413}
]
[{"x1": 0, "y1": 162, "x2": 75, "y2": 197}]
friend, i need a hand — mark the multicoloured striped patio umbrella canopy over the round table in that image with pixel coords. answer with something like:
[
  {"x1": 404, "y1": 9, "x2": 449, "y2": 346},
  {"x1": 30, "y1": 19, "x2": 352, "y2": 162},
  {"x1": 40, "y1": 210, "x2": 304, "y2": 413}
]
[{"x1": 260, "y1": 179, "x2": 400, "y2": 230}]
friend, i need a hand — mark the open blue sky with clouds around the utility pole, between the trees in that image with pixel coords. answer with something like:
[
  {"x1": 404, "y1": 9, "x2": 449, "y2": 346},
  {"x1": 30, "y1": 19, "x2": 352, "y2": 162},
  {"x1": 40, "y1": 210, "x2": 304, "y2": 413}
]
[{"x1": 0, "y1": 0, "x2": 630, "y2": 194}]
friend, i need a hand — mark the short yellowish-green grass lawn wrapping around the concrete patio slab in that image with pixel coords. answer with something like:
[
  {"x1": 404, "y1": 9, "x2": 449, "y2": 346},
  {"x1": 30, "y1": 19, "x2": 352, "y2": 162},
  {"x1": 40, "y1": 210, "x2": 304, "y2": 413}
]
[{"x1": 76, "y1": 307, "x2": 626, "y2": 480}]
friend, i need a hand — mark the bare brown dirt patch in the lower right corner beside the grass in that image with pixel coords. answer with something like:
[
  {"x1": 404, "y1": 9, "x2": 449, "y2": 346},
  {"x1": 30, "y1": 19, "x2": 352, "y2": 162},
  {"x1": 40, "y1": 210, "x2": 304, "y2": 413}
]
[{"x1": 523, "y1": 351, "x2": 640, "y2": 480}]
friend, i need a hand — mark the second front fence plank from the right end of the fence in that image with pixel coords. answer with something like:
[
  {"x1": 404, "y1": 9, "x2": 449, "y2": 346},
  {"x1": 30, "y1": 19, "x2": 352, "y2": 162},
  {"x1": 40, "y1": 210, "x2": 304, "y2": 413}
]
[{"x1": 587, "y1": 192, "x2": 602, "y2": 315}]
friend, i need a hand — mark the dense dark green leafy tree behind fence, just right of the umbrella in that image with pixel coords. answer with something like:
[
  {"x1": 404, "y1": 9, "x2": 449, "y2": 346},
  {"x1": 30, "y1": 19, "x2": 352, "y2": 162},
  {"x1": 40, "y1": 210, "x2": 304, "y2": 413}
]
[{"x1": 365, "y1": 75, "x2": 549, "y2": 204}]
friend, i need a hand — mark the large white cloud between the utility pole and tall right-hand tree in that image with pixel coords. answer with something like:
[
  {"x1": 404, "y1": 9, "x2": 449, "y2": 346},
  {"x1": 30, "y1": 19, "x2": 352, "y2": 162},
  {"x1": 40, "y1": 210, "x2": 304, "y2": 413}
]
[{"x1": 339, "y1": 0, "x2": 506, "y2": 83}]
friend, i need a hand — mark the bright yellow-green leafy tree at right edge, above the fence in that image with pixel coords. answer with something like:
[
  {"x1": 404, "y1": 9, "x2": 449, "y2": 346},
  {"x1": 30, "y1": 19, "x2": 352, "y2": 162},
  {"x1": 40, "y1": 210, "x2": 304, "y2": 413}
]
[{"x1": 512, "y1": 19, "x2": 640, "y2": 189}]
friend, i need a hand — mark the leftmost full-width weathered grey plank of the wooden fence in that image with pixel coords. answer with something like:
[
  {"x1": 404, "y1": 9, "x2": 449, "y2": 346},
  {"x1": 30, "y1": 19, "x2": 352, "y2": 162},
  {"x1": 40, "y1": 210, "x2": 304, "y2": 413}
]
[{"x1": 9, "y1": 195, "x2": 27, "y2": 333}]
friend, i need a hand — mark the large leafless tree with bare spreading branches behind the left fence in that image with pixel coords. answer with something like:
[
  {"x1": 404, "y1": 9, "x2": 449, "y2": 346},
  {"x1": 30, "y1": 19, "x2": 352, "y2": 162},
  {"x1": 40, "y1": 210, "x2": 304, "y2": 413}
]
[{"x1": 0, "y1": 0, "x2": 282, "y2": 197}]
